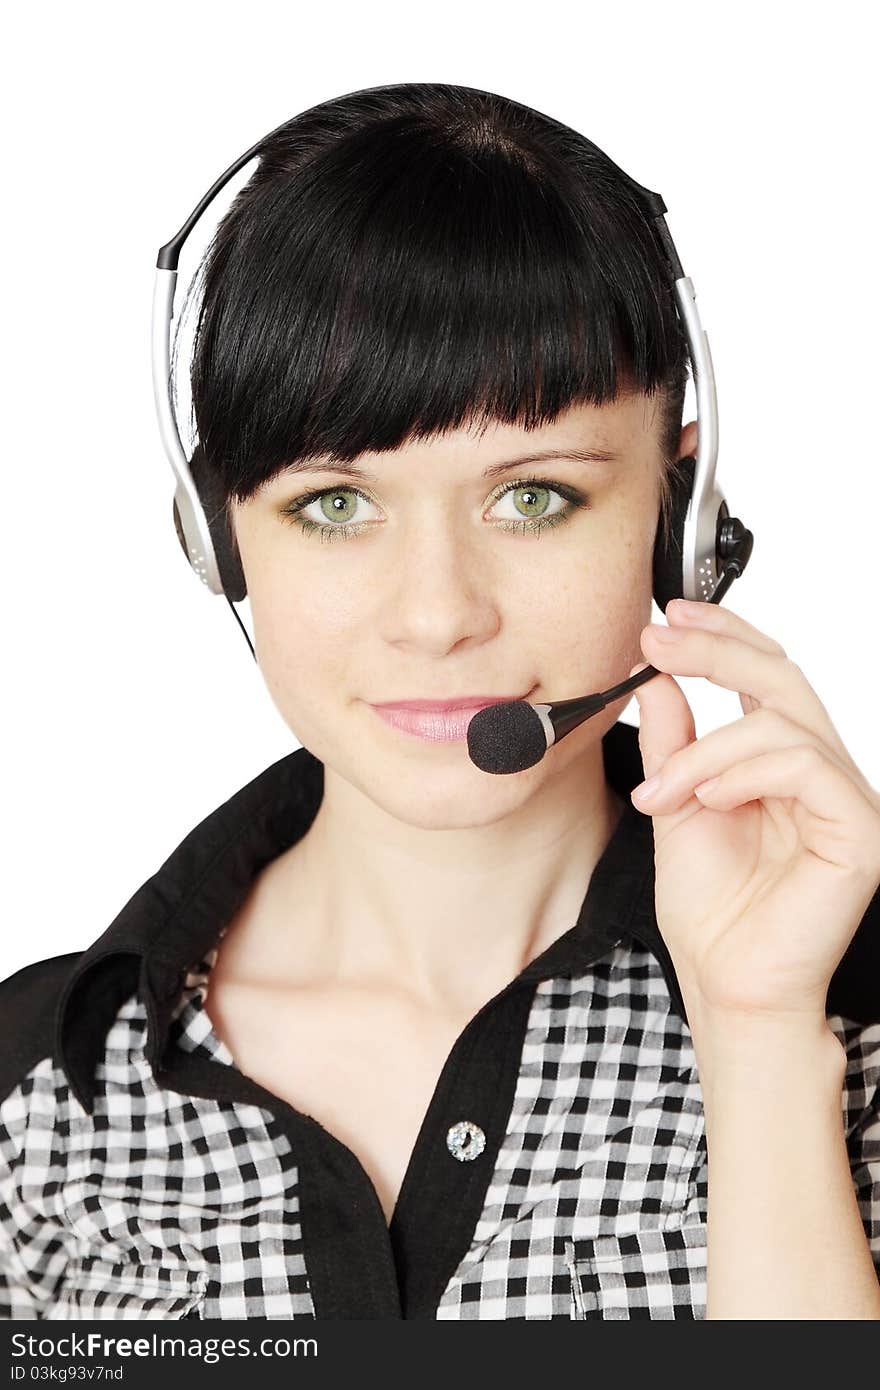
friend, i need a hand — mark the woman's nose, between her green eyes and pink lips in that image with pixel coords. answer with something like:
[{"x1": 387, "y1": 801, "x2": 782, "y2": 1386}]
[{"x1": 381, "y1": 509, "x2": 499, "y2": 656}]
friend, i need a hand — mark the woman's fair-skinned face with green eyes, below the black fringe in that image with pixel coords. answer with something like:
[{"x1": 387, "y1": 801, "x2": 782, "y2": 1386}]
[{"x1": 232, "y1": 395, "x2": 678, "y2": 828}]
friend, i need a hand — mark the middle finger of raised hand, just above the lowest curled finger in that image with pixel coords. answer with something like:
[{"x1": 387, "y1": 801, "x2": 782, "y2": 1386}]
[{"x1": 631, "y1": 709, "x2": 851, "y2": 815}]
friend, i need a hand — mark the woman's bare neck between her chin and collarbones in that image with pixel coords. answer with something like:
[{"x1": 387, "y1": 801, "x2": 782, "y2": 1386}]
[{"x1": 226, "y1": 742, "x2": 626, "y2": 1015}]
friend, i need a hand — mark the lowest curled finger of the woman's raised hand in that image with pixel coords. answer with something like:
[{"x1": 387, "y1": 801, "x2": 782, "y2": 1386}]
[{"x1": 694, "y1": 744, "x2": 880, "y2": 883}]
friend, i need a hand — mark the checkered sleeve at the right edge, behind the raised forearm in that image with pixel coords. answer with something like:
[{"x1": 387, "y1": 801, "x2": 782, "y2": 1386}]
[{"x1": 829, "y1": 1016, "x2": 880, "y2": 1276}]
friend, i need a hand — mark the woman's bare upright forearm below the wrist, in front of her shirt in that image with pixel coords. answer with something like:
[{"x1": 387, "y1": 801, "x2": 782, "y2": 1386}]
[{"x1": 694, "y1": 1020, "x2": 880, "y2": 1319}]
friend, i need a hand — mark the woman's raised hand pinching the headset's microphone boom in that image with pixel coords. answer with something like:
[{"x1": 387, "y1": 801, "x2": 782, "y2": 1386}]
[{"x1": 630, "y1": 599, "x2": 880, "y2": 1020}]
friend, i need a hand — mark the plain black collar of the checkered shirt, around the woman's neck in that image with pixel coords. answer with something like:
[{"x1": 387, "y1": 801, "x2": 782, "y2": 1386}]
[{"x1": 54, "y1": 720, "x2": 880, "y2": 1109}]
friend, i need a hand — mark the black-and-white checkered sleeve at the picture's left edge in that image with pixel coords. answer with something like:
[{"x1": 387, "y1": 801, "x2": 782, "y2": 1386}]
[{"x1": 0, "y1": 1059, "x2": 67, "y2": 1319}]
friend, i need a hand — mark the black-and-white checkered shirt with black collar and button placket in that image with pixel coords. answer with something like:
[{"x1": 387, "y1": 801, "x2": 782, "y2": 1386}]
[{"x1": 0, "y1": 721, "x2": 880, "y2": 1319}]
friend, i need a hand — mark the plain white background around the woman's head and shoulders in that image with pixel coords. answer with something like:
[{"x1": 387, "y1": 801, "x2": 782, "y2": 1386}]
[{"x1": 0, "y1": 0, "x2": 880, "y2": 977}]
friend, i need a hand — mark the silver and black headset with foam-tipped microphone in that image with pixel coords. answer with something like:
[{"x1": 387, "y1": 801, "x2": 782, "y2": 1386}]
[{"x1": 152, "y1": 83, "x2": 753, "y2": 773}]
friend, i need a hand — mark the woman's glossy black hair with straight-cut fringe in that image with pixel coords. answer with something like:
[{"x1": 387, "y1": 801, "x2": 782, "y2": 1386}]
[{"x1": 178, "y1": 82, "x2": 688, "y2": 547}]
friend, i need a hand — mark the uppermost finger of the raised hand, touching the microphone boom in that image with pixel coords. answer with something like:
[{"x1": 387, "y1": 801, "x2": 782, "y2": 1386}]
[{"x1": 641, "y1": 617, "x2": 869, "y2": 791}]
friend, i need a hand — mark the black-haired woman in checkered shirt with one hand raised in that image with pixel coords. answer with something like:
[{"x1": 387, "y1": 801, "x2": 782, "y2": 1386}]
[{"x1": 0, "y1": 83, "x2": 880, "y2": 1319}]
